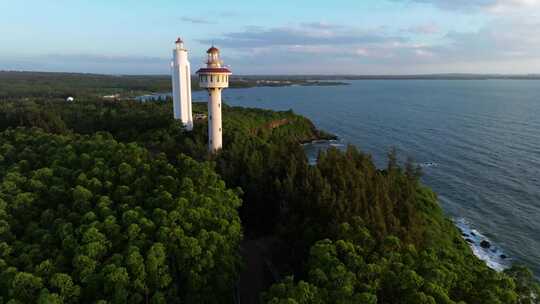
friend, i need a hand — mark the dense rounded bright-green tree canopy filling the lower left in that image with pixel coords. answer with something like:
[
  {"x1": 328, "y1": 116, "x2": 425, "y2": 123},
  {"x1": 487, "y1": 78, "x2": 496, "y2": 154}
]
[{"x1": 0, "y1": 129, "x2": 242, "y2": 303}]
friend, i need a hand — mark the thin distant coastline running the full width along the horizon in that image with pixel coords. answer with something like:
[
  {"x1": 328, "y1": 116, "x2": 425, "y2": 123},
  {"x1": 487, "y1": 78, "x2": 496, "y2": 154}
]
[{"x1": 0, "y1": 70, "x2": 540, "y2": 100}]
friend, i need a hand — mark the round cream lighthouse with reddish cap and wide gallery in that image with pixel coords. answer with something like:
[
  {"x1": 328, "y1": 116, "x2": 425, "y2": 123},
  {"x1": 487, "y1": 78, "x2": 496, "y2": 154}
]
[{"x1": 197, "y1": 46, "x2": 232, "y2": 152}]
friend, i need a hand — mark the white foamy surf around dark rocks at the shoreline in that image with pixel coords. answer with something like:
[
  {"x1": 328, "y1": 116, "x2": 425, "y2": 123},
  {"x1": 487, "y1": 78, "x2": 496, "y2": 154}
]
[{"x1": 454, "y1": 218, "x2": 511, "y2": 271}]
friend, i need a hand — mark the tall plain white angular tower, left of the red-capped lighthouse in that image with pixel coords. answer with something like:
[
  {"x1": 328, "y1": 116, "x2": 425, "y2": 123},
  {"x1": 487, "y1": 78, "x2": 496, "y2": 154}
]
[{"x1": 171, "y1": 38, "x2": 193, "y2": 131}]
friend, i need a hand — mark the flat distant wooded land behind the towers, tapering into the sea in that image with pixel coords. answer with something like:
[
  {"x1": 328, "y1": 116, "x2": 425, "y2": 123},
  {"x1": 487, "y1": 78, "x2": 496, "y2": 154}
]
[{"x1": 0, "y1": 71, "x2": 346, "y2": 100}]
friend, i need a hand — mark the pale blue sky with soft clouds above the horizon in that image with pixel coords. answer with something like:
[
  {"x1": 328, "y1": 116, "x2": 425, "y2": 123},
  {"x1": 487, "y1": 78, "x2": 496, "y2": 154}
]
[{"x1": 0, "y1": 0, "x2": 540, "y2": 75}]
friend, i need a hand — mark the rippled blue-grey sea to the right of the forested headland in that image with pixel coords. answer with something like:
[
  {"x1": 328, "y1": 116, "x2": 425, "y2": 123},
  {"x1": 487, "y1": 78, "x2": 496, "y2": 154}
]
[{"x1": 193, "y1": 80, "x2": 540, "y2": 276}]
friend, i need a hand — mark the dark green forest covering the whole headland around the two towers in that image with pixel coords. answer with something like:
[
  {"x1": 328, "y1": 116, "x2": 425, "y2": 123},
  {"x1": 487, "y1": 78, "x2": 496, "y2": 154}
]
[{"x1": 0, "y1": 72, "x2": 540, "y2": 304}]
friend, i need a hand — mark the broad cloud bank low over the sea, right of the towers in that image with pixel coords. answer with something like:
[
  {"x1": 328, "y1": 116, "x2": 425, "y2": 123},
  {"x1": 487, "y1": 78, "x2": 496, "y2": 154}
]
[{"x1": 202, "y1": 15, "x2": 540, "y2": 74}]
